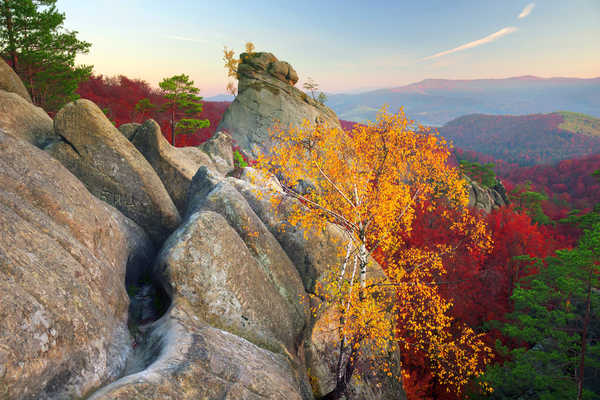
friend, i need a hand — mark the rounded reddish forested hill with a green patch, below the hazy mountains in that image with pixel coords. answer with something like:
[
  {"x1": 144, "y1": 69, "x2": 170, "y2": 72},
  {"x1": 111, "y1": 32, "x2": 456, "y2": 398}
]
[{"x1": 438, "y1": 112, "x2": 600, "y2": 166}]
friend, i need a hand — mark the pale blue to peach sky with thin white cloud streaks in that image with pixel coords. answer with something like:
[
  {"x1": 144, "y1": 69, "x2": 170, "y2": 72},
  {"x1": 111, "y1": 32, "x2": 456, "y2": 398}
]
[{"x1": 57, "y1": 0, "x2": 600, "y2": 97}]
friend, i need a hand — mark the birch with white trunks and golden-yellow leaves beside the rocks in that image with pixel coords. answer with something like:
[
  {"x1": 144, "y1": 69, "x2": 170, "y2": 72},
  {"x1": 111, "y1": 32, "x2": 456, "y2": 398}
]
[{"x1": 258, "y1": 109, "x2": 492, "y2": 399}]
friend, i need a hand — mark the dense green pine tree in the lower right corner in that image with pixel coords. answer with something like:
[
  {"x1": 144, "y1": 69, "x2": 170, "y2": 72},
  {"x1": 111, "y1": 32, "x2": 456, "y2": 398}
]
[{"x1": 483, "y1": 223, "x2": 600, "y2": 400}]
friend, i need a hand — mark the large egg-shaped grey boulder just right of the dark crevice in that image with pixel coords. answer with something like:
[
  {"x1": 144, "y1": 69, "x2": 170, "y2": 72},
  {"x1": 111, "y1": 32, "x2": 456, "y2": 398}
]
[{"x1": 155, "y1": 211, "x2": 298, "y2": 354}]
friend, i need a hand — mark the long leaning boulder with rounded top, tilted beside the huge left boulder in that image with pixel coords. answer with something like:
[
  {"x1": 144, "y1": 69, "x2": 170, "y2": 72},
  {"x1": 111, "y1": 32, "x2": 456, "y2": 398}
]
[{"x1": 46, "y1": 99, "x2": 181, "y2": 244}]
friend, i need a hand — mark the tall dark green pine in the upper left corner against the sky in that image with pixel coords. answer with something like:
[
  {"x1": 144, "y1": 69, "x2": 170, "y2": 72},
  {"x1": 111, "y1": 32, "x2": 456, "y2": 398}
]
[{"x1": 0, "y1": 0, "x2": 92, "y2": 112}]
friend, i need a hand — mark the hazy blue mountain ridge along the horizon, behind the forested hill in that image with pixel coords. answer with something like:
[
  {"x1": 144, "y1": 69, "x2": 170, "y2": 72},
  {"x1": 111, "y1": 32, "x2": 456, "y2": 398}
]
[{"x1": 326, "y1": 76, "x2": 600, "y2": 126}]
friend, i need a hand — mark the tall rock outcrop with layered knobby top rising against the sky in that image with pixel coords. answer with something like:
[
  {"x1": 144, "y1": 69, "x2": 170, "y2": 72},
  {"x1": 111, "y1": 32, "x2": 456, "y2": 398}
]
[{"x1": 217, "y1": 53, "x2": 340, "y2": 157}]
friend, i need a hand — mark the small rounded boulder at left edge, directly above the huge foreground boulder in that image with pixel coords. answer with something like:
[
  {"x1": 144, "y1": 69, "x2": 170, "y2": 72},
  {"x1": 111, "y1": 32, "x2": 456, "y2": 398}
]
[{"x1": 0, "y1": 90, "x2": 58, "y2": 148}]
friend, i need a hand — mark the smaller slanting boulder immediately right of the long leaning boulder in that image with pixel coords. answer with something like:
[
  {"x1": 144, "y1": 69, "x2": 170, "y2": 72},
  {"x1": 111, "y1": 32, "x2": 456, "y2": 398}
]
[{"x1": 130, "y1": 119, "x2": 205, "y2": 213}]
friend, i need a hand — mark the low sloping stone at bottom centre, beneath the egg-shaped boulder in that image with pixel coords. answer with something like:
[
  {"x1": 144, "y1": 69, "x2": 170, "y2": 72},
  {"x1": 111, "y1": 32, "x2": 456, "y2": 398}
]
[{"x1": 90, "y1": 298, "x2": 312, "y2": 400}]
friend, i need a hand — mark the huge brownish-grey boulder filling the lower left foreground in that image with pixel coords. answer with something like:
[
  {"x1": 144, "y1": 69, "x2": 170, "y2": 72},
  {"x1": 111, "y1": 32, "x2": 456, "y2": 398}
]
[{"x1": 0, "y1": 131, "x2": 153, "y2": 399}]
